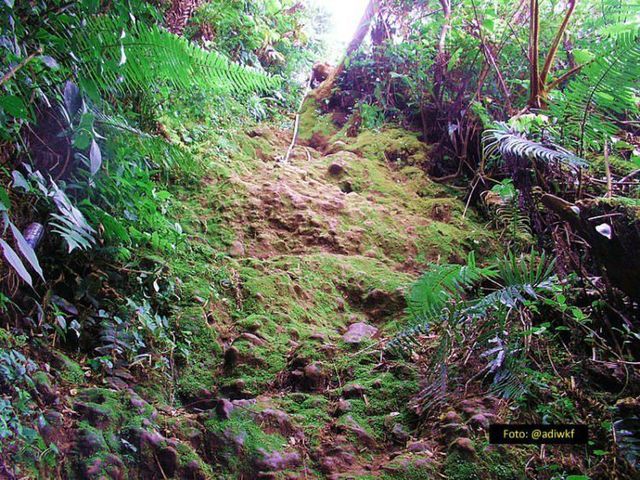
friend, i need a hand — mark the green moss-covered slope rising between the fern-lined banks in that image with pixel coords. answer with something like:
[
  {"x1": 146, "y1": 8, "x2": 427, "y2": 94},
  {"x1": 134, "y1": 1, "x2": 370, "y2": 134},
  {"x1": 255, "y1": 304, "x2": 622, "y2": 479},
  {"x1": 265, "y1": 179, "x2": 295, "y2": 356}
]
[{"x1": 104, "y1": 105, "x2": 510, "y2": 479}]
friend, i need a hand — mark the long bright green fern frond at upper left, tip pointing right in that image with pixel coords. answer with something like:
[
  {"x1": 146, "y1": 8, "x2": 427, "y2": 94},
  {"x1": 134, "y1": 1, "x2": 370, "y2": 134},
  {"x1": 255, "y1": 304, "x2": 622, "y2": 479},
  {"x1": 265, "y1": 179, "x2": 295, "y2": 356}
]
[{"x1": 69, "y1": 16, "x2": 279, "y2": 93}]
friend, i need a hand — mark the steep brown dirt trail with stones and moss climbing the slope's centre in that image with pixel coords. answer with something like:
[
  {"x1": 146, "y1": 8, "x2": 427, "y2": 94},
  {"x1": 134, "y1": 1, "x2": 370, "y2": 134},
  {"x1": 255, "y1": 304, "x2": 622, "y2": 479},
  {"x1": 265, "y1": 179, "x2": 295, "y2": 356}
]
[{"x1": 168, "y1": 121, "x2": 498, "y2": 478}]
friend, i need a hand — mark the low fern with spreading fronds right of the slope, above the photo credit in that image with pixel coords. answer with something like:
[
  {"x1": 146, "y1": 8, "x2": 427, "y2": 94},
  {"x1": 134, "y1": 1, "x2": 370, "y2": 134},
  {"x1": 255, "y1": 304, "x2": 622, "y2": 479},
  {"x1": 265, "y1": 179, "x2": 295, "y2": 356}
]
[{"x1": 386, "y1": 251, "x2": 555, "y2": 415}]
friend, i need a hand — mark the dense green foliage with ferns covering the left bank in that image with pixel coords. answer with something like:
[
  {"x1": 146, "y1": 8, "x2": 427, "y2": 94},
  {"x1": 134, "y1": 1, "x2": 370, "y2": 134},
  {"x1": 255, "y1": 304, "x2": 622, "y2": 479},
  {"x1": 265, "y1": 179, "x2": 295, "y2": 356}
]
[{"x1": 0, "y1": 1, "x2": 317, "y2": 478}]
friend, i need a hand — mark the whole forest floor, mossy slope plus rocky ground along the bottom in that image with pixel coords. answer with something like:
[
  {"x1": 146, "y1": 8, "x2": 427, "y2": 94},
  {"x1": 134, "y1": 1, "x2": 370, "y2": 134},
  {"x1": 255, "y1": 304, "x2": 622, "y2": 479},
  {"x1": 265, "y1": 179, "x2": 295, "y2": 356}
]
[{"x1": 15, "y1": 103, "x2": 535, "y2": 480}]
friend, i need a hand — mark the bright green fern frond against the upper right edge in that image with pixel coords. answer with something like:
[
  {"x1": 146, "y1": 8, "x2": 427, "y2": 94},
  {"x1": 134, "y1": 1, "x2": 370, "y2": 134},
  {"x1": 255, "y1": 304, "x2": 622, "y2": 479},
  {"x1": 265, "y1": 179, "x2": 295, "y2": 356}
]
[{"x1": 549, "y1": 29, "x2": 640, "y2": 155}]
